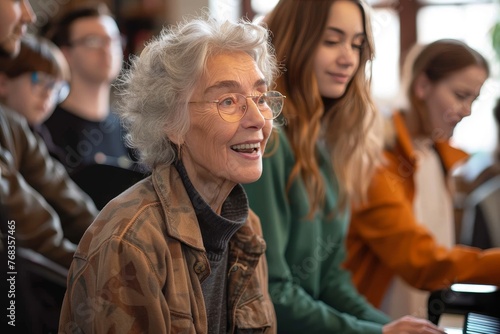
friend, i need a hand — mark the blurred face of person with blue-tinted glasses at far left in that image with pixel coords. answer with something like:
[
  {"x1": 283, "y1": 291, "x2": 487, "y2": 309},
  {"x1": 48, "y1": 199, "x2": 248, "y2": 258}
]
[{"x1": 0, "y1": 72, "x2": 64, "y2": 126}]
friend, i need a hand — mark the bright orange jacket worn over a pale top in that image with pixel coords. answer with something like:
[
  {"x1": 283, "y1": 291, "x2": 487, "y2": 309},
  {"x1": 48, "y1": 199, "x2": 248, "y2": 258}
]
[{"x1": 345, "y1": 114, "x2": 500, "y2": 307}]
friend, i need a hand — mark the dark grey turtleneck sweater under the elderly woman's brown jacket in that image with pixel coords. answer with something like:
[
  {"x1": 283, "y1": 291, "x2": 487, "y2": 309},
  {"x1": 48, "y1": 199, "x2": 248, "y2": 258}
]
[{"x1": 174, "y1": 160, "x2": 249, "y2": 334}]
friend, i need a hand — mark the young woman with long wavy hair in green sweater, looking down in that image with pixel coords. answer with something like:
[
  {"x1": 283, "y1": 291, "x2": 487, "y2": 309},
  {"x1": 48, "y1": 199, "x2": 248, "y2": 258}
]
[{"x1": 245, "y1": 0, "x2": 443, "y2": 334}]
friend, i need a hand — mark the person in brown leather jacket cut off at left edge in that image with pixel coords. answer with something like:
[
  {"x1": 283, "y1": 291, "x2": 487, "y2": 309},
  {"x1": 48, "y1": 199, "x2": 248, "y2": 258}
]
[{"x1": 0, "y1": 0, "x2": 97, "y2": 334}]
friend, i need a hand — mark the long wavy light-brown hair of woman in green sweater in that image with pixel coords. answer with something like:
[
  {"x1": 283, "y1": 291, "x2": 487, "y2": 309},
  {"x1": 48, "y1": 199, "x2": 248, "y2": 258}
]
[{"x1": 265, "y1": 0, "x2": 382, "y2": 215}]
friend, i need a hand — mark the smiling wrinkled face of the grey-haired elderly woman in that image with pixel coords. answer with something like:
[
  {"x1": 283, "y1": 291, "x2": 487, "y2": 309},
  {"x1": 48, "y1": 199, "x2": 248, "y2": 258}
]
[{"x1": 182, "y1": 52, "x2": 273, "y2": 190}]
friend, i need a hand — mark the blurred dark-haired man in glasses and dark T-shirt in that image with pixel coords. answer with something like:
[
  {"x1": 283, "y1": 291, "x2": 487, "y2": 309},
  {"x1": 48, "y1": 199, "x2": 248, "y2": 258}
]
[{"x1": 42, "y1": 1, "x2": 144, "y2": 209}]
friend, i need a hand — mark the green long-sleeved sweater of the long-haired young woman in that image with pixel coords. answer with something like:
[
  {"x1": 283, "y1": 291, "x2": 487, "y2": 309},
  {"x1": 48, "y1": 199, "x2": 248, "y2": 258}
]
[{"x1": 245, "y1": 131, "x2": 389, "y2": 334}]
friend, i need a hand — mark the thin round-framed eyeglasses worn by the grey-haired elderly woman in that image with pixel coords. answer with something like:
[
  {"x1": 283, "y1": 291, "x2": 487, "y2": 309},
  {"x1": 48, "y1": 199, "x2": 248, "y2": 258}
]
[{"x1": 189, "y1": 91, "x2": 286, "y2": 123}]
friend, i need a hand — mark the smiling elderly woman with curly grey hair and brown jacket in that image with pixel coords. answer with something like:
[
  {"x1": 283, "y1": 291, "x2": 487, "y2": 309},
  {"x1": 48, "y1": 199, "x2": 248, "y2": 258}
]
[{"x1": 59, "y1": 14, "x2": 284, "y2": 333}]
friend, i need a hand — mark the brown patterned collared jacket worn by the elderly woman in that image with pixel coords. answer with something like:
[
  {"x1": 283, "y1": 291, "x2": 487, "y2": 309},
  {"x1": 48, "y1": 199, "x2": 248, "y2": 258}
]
[{"x1": 59, "y1": 166, "x2": 276, "y2": 334}]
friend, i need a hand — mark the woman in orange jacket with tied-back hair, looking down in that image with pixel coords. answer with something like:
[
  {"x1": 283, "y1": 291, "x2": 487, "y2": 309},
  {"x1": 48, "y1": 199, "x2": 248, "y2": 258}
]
[{"x1": 345, "y1": 39, "x2": 500, "y2": 317}]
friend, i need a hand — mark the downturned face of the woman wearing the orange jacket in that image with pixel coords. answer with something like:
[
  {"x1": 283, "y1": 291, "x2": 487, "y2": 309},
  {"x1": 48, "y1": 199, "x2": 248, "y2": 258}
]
[{"x1": 416, "y1": 65, "x2": 487, "y2": 140}]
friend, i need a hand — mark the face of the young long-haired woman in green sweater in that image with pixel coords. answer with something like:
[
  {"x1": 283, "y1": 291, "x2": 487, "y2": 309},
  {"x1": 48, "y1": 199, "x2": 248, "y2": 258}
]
[{"x1": 314, "y1": 1, "x2": 365, "y2": 98}]
